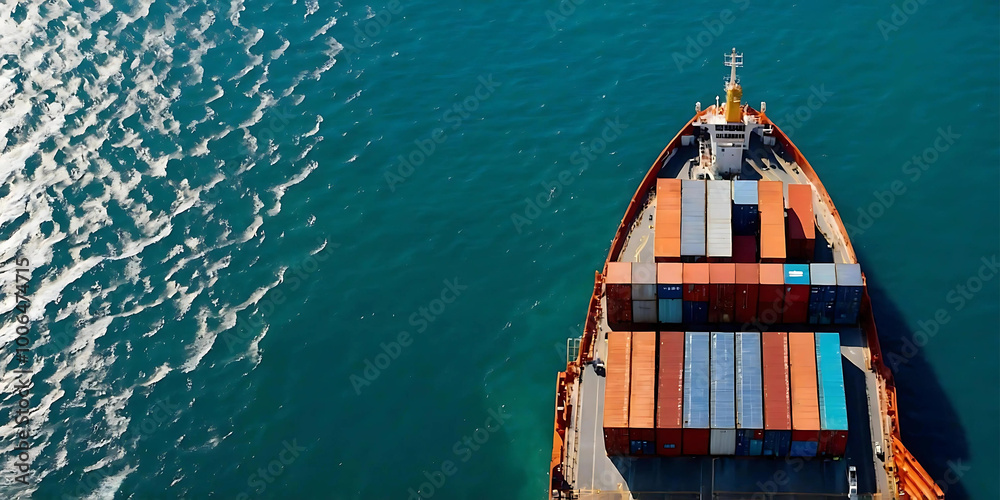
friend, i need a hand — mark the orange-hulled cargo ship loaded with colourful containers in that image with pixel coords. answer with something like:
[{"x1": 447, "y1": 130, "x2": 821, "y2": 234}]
[{"x1": 548, "y1": 49, "x2": 944, "y2": 500}]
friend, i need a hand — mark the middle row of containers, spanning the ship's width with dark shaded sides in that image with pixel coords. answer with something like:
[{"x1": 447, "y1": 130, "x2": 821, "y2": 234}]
[{"x1": 605, "y1": 262, "x2": 864, "y2": 330}]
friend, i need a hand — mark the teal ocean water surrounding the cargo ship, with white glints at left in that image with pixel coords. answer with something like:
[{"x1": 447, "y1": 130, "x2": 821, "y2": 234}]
[{"x1": 0, "y1": 0, "x2": 1000, "y2": 499}]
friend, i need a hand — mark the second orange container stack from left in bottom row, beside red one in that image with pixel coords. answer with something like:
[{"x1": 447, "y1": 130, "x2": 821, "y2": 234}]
[{"x1": 628, "y1": 332, "x2": 656, "y2": 455}]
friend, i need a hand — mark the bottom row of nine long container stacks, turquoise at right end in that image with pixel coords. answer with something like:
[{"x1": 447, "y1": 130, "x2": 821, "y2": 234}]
[{"x1": 604, "y1": 332, "x2": 848, "y2": 457}]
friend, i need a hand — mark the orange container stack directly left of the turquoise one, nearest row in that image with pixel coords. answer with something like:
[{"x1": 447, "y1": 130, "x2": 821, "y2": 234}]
[{"x1": 788, "y1": 332, "x2": 820, "y2": 457}]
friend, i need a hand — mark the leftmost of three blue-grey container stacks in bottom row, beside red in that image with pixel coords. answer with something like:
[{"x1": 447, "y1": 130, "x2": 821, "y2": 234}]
[{"x1": 680, "y1": 332, "x2": 711, "y2": 455}]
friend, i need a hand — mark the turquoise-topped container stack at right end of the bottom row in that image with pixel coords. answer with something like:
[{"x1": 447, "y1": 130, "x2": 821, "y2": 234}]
[{"x1": 816, "y1": 332, "x2": 847, "y2": 457}]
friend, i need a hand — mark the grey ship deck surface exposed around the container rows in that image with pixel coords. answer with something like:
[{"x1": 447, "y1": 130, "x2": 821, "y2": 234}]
[{"x1": 564, "y1": 136, "x2": 891, "y2": 500}]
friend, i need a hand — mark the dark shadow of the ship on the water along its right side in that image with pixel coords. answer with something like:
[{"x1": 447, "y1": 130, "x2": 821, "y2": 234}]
[{"x1": 858, "y1": 258, "x2": 970, "y2": 500}]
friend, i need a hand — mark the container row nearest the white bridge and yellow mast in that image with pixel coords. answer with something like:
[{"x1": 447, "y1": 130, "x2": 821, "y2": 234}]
[{"x1": 653, "y1": 179, "x2": 816, "y2": 263}]
